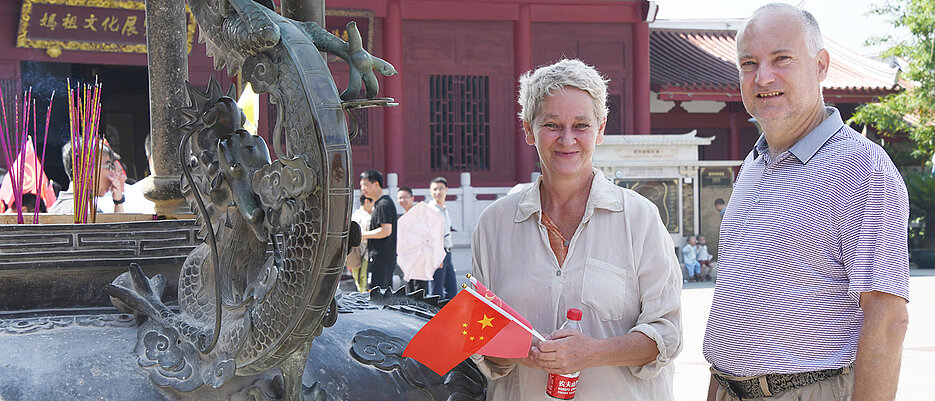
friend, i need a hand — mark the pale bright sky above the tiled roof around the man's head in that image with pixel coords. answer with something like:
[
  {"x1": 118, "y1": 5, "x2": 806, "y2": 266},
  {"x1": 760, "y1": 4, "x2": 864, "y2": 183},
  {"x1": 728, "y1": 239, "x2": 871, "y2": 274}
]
[{"x1": 656, "y1": 0, "x2": 892, "y2": 55}]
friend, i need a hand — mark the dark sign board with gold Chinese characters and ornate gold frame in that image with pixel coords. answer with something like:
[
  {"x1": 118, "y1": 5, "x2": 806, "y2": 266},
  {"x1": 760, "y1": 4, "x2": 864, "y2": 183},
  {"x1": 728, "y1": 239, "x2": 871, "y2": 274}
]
[{"x1": 16, "y1": 0, "x2": 195, "y2": 57}]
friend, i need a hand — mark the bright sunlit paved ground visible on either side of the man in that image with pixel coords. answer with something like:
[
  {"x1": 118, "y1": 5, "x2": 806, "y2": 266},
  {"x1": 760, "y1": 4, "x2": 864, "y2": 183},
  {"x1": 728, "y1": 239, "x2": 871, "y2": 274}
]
[{"x1": 368, "y1": 248, "x2": 935, "y2": 401}]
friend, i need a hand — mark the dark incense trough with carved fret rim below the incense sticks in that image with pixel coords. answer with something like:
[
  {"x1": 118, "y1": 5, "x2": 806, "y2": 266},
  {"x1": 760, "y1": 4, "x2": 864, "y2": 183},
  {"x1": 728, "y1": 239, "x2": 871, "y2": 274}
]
[{"x1": 0, "y1": 216, "x2": 202, "y2": 310}]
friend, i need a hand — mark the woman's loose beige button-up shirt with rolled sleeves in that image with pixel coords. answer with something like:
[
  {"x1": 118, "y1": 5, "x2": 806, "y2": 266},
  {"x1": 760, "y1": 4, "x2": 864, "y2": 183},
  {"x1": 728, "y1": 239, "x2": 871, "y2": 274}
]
[{"x1": 471, "y1": 169, "x2": 682, "y2": 401}]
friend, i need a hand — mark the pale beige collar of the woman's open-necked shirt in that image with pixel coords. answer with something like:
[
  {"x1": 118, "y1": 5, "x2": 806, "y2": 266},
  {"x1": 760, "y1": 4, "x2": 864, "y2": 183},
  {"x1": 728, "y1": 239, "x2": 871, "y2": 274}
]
[{"x1": 513, "y1": 168, "x2": 623, "y2": 223}]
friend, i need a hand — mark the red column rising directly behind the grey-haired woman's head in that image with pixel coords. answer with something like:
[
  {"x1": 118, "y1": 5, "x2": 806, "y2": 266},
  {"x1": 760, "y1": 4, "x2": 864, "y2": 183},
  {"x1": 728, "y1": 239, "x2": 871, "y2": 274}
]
[{"x1": 513, "y1": 4, "x2": 538, "y2": 182}]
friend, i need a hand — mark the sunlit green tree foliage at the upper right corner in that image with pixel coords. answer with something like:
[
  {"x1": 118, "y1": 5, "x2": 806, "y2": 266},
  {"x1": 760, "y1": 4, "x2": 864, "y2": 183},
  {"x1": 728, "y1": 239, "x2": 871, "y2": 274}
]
[{"x1": 848, "y1": 0, "x2": 935, "y2": 166}]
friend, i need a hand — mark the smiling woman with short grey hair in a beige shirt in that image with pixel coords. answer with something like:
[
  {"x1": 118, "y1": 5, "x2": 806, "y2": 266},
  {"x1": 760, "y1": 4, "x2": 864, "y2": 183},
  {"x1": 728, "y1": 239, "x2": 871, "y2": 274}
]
[{"x1": 471, "y1": 60, "x2": 682, "y2": 401}]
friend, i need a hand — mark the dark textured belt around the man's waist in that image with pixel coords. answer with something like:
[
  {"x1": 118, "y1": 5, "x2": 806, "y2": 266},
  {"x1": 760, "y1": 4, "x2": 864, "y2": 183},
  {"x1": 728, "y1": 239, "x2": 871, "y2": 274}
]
[{"x1": 711, "y1": 366, "x2": 853, "y2": 398}]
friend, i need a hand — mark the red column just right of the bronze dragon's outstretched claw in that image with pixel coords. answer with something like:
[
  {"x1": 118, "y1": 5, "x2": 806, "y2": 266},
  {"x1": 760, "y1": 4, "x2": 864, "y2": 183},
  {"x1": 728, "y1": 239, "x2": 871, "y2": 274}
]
[{"x1": 383, "y1": 0, "x2": 405, "y2": 175}]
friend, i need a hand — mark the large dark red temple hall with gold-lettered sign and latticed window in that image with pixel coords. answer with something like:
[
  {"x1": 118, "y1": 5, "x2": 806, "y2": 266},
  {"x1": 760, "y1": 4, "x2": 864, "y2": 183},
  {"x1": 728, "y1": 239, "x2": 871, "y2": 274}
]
[{"x1": 0, "y1": 0, "x2": 656, "y2": 186}]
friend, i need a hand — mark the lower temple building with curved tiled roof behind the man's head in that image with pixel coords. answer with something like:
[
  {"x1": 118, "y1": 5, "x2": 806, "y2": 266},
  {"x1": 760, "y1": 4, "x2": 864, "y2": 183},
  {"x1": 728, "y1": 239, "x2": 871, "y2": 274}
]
[{"x1": 649, "y1": 20, "x2": 901, "y2": 160}]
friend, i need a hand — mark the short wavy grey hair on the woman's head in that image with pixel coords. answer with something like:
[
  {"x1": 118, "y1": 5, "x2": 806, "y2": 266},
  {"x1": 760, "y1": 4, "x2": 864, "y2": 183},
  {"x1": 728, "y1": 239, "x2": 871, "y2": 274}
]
[{"x1": 517, "y1": 59, "x2": 610, "y2": 124}]
